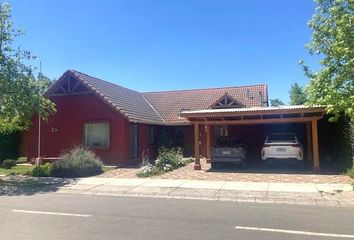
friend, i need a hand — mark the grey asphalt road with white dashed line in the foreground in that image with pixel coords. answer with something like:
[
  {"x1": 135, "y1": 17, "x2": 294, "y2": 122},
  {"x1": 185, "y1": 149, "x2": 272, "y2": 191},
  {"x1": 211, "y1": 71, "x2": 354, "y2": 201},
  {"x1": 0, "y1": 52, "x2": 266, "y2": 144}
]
[{"x1": 0, "y1": 193, "x2": 354, "y2": 240}]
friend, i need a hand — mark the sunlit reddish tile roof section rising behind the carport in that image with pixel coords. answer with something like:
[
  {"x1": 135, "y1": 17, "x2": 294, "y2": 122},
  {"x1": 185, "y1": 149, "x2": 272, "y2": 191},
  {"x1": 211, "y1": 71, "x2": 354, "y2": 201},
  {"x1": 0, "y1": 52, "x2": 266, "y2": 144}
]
[{"x1": 143, "y1": 84, "x2": 268, "y2": 125}]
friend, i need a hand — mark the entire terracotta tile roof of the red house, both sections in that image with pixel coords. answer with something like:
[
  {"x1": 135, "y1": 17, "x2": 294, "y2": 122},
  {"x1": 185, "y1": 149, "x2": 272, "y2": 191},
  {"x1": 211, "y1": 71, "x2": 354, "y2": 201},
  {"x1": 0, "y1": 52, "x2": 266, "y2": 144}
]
[{"x1": 46, "y1": 70, "x2": 268, "y2": 125}]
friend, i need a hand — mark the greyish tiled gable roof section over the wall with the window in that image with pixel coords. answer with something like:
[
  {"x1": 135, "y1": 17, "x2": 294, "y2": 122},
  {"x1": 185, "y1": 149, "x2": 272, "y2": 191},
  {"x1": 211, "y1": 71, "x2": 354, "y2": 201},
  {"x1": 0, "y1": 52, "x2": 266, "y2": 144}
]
[{"x1": 46, "y1": 70, "x2": 164, "y2": 124}]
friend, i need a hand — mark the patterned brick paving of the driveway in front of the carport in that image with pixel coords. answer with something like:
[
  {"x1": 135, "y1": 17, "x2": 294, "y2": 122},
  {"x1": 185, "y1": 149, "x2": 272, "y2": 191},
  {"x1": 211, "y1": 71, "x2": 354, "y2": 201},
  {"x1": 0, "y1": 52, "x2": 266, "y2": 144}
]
[{"x1": 101, "y1": 160, "x2": 352, "y2": 183}]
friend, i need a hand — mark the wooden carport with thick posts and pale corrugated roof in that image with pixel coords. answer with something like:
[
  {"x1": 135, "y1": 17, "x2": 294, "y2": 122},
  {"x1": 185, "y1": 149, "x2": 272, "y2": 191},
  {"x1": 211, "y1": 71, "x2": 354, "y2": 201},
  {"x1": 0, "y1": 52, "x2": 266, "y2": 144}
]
[{"x1": 180, "y1": 105, "x2": 325, "y2": 172}]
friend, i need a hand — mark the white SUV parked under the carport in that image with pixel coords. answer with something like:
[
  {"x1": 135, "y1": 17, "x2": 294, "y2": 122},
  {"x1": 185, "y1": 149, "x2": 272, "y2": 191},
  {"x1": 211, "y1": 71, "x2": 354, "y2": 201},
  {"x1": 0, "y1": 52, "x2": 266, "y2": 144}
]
[{"x1": 261, "y1": 133, "x2": 304, "y2": 161}]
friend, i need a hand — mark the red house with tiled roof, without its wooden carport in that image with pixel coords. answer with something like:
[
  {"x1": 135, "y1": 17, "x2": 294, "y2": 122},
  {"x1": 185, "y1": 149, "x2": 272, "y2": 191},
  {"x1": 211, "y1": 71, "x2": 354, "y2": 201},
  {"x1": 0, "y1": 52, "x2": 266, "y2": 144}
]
[{"x1": 24, "y1": 70, "x2": 268, "y2": 165}]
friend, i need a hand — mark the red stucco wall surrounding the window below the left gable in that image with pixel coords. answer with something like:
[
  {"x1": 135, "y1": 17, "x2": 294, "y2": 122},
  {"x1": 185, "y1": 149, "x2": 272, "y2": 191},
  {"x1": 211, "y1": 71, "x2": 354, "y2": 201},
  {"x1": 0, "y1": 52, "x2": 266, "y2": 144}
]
[{"x1": 23, "y1": 95, "x2": 131, "y2": 164}]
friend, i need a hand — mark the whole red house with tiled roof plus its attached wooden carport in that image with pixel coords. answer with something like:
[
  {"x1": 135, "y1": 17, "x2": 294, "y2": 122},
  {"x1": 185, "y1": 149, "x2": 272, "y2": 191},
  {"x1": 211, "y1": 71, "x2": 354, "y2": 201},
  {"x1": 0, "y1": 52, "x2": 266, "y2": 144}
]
[{"x1": 23, "y1": 70, "x2": 323, "y2": 169}]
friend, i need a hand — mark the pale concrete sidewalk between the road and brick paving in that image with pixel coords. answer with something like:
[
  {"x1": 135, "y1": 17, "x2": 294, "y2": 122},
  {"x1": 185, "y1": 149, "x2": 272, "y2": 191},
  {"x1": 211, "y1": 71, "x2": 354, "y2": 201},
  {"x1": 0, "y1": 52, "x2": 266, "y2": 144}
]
[{"x1": 58, "y1": 177, "x2": 354, "y2": 207}]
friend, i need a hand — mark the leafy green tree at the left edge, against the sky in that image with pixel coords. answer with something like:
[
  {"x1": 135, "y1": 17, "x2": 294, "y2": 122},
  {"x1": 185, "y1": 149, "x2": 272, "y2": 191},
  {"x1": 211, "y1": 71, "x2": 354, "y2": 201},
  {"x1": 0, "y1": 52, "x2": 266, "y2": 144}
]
[{"x1": 0, "y1": 3, "x2": 54, "y2": 132}]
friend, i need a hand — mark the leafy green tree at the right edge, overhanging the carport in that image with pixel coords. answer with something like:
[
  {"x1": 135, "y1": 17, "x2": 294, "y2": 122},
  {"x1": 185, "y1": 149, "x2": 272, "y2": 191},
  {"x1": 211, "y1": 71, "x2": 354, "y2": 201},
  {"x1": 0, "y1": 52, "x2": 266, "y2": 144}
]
[{"x1": 302, "y1": 0, "x2": 354, "y2": 122}]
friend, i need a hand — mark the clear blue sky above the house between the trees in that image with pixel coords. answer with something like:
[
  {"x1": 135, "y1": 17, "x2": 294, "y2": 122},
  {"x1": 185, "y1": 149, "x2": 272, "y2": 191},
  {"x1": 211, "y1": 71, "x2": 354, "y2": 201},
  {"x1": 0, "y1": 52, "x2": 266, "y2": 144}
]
[{"x1": 8, "y1": 0, "x2": 316, "y2": 102}]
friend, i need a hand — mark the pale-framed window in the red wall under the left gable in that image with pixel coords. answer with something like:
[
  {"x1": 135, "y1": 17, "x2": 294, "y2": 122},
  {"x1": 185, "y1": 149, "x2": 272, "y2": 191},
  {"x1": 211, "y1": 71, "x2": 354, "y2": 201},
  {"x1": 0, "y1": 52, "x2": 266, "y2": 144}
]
[{"x1": 84, "y1": 122, "x2": 109, "y2": 148}]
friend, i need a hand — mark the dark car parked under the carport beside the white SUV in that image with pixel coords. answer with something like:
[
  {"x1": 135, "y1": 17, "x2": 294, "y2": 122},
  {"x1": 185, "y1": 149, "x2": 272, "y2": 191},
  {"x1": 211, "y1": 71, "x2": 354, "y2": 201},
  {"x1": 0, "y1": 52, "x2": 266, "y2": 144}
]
[{"x1": 211, "y1": 137, "x2": 248, "y2": 168}]
